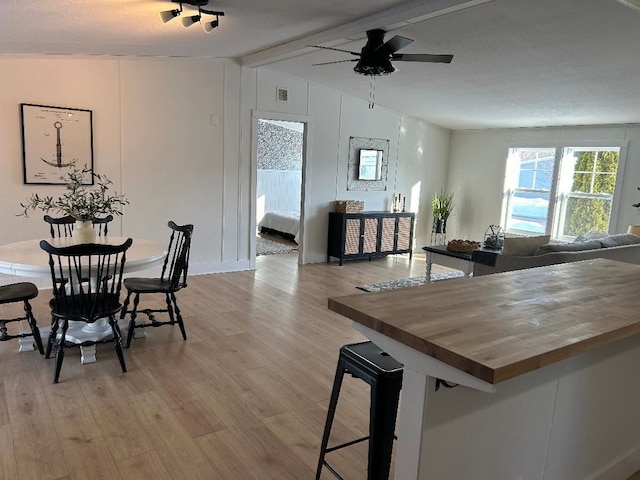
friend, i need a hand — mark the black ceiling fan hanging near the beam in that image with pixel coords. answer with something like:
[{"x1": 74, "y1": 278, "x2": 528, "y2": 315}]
[{"x1": 309, "y1": 29, "x2": 453, "y2": 76}]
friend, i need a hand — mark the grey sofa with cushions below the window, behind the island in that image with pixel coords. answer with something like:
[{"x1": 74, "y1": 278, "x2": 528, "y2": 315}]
[{"x1": 471, "y1": 232, "x2": 640, "y2": 277}]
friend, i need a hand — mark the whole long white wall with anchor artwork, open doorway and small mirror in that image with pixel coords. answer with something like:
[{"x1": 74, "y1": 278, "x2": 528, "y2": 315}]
[{"x1": 0, "y1": 57, "x2": 449, "y2": 273}]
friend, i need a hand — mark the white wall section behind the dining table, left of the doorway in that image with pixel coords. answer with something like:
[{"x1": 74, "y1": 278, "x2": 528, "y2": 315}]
[{"x1": 0, "y1": 57, "x2": 249, "y2": 282}]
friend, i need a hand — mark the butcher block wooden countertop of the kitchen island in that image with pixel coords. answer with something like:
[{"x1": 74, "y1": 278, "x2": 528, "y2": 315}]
[{"x1": 329, "y1": 259, "x2": 640, "y2": 384}]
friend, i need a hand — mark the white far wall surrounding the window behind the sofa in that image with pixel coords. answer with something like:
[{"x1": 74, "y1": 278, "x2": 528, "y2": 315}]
[{"x1": 447, "y1": 125, "x2": 640, "y2": 240}]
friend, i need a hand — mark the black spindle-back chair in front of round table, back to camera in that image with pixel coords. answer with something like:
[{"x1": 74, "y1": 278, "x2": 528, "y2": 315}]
[{"x1": 40, "y1": 238, "x2": 133, "y2": 383}]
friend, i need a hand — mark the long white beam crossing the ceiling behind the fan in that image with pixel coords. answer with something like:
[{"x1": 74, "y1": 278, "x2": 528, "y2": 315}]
[{"x1": 240, "y1": 0, "x2": 494, "y2": 67}]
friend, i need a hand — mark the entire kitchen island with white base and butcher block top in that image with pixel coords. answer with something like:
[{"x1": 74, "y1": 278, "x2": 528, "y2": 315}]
[{"x1": 329, "y1": 259, "x2": 640, "y2": 480}]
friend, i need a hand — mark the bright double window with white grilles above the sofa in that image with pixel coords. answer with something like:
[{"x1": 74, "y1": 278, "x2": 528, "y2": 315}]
[{"x1": 503, "y1": 147, "x2": 620, "y2": 240}]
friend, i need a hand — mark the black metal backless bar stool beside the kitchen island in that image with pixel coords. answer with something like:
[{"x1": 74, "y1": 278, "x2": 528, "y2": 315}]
[{"x1": 316, "y1": 342, "x2": 402, "y2": 480}]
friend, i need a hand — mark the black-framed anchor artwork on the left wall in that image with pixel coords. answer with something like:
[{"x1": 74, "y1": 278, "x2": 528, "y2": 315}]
[{"x1": 20, "y1": 103, "x2": 93, "y2": 185}]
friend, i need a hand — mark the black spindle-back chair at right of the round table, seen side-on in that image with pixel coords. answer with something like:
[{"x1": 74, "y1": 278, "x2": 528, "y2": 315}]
[{"x1": 120, "y1": 221, "x2": 193, "y2": 348}]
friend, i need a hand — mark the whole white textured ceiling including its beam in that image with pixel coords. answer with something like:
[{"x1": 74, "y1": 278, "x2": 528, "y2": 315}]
[{"x1": 0, "y1": 0, "x2": 640, "y2": 129}]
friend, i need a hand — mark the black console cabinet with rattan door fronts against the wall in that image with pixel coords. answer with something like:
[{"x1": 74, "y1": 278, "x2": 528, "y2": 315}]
[{"x1": 327, "y1": 212, "x2": 415, "y2": 265}]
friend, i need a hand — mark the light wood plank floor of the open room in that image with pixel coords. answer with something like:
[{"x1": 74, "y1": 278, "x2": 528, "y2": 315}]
[{"x1": 0, "y1": 253, "x2": 436, "y2": 480}]
